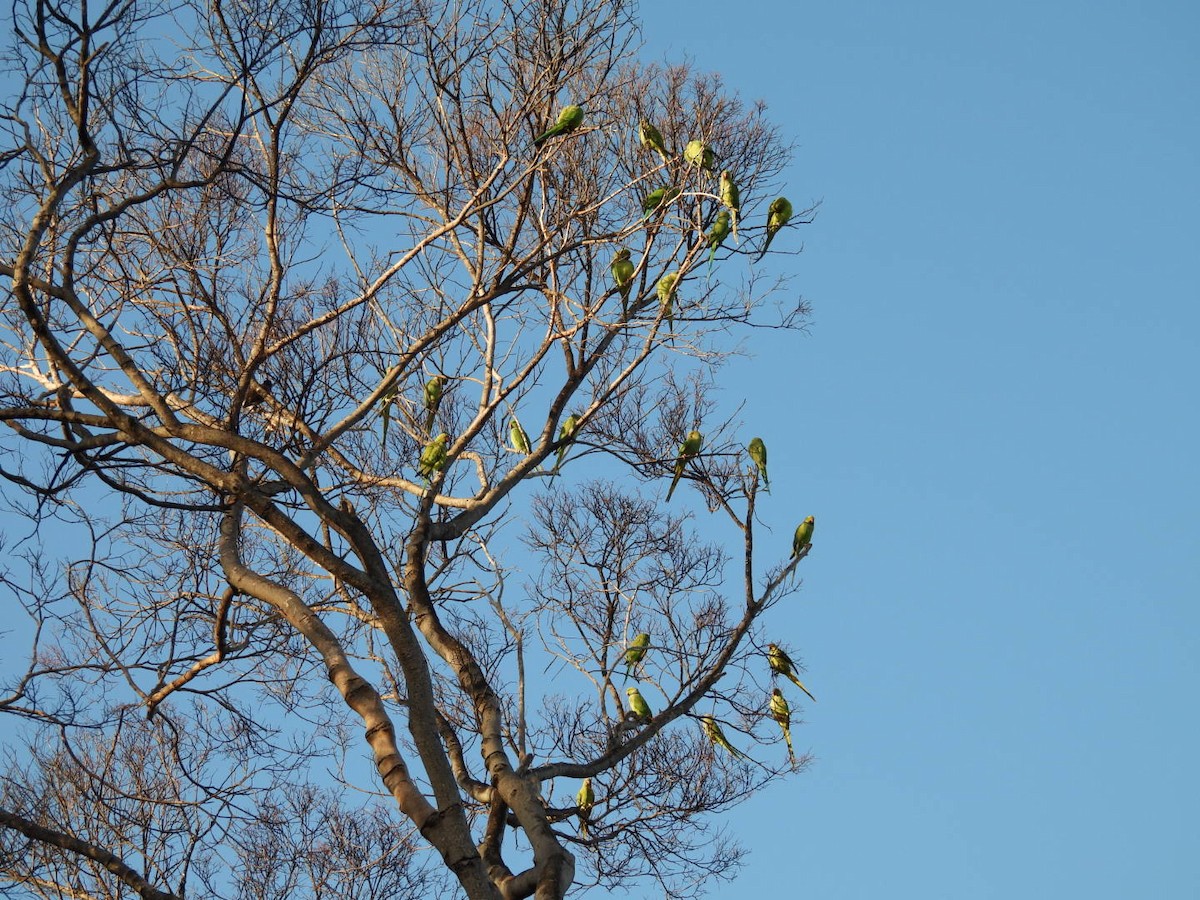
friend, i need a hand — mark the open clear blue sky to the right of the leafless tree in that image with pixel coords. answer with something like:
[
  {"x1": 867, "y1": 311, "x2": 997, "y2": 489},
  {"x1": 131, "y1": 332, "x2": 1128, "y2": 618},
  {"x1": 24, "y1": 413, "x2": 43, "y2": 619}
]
[{"x1": 643, "y1": 0, "x2": 1200, "y2": 900}]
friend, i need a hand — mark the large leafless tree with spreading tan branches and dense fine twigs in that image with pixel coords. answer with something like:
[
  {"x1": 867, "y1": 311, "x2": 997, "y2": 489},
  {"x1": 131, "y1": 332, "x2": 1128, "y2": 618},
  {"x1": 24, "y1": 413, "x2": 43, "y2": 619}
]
[{"x1": 0, "y1": 0, "x2": 809, "y2": 900}]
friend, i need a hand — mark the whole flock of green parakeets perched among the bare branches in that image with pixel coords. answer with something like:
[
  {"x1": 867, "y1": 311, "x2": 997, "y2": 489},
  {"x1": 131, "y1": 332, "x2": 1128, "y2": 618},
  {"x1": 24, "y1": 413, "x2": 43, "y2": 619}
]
[{"x1": 403, "y1": 106, "x2": 816, "y2": 838}]
